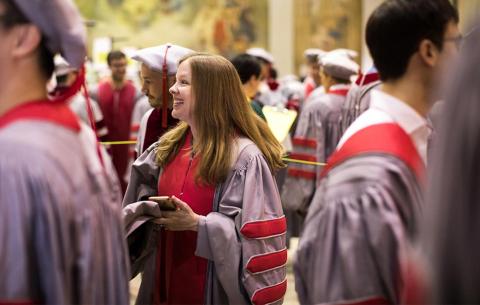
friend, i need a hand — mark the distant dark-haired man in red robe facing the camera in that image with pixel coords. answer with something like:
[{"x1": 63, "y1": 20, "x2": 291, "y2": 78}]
[{"x1": 94, "y1": 51, "x2": 140, "y2": 193}]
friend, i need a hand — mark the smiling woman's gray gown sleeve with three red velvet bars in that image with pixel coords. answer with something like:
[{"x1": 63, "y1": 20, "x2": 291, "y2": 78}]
[{"x1": 196, "y1": 145, "x2": 287, "y2": 304}]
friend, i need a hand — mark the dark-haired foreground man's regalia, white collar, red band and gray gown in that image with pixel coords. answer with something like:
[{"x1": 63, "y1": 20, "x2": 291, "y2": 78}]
[{"x1": 295, "y1": 86, "x2": 428, "y2": 304}]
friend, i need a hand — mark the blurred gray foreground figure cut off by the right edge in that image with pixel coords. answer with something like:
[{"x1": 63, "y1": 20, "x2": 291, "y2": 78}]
[{"x1": 420, "y1": 23, "x2": 480, "y2": 304}]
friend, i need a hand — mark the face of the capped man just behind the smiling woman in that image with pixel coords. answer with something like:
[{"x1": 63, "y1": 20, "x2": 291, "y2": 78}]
[{"x1": 140, "y1": 64, "x2": 175, "y2": 108}]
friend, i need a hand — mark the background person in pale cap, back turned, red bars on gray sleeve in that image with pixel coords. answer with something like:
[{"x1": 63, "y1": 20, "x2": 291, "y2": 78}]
[{"x1": 282, "y1": 50, "x2": 358, "y2": 215}]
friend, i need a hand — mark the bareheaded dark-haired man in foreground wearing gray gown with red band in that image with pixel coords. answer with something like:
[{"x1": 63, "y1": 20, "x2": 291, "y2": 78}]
[{"x1": 294, "y1": 0, "x2": 459, "y2": 304}]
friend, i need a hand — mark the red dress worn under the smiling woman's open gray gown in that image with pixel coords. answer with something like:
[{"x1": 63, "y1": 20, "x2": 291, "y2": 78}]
[{"x1": 153, "y1": 132, "x2": 215, "y2": 304}]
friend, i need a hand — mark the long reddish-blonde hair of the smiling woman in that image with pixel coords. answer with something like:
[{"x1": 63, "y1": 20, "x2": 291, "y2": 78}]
[{"x1": 157, "y1": 53, "x2": 284, "y2": 184}]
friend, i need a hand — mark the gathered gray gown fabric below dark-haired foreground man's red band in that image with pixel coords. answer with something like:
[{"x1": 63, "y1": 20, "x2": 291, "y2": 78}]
[{"x1": 294, "y1": 124, "x2": 422, "y2": 304}]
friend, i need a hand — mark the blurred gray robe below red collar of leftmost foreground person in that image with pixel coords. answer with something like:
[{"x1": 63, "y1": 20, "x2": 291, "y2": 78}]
[{"x1": 0, "y1": 119, "x2": 129, "y2": 304}]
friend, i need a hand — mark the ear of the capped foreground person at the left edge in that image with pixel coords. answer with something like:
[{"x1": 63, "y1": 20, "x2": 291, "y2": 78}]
[{"x1": 12, "y1": 24, "x2": 42, "y2": 57}]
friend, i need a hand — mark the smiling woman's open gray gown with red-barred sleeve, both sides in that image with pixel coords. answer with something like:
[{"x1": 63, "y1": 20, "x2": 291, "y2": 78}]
[{"x1": 123, "y1": 138, "x2": 287, "y2": 304}]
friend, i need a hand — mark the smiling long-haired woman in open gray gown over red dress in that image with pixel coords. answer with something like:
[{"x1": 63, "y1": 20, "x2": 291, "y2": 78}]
[{"x1": 123, "y1": 54, "x2": 287, "y2": 304}]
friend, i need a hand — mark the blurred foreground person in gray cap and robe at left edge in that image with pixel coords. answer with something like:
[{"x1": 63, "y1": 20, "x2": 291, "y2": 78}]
[{"x1": 0, "y1": 0, "x2": 129, "y2": 305}]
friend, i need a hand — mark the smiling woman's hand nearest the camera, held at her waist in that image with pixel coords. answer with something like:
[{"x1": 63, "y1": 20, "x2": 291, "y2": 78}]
[{"x1": 153, "y1": 196, "x2": 200, "y2": 231}]
